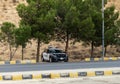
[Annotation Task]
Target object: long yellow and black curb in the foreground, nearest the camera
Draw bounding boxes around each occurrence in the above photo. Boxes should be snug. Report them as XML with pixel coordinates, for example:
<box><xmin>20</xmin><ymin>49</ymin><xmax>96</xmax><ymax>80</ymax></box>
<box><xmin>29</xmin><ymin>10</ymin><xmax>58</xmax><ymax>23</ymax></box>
<box><xmin>0</xmin><ymin>70</ymin><xmax>120</xmax><ymax>81</ymax></box>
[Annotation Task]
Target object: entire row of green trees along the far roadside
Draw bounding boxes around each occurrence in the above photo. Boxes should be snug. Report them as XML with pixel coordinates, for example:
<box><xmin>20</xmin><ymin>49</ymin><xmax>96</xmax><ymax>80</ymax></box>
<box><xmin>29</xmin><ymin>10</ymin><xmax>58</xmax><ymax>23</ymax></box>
<box><xmin>1</xmin><ymin>0</ymin><xmax>120</xmax><ymax>62</ymax></box>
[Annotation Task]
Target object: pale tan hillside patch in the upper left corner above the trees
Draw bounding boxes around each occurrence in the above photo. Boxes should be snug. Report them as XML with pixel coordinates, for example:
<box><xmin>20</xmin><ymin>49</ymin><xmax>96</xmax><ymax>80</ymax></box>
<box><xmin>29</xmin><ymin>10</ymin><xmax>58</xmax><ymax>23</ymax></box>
<box><xmin>0</xmin><ymin>0</ymin><xmax>26</xmax><ymax>25</ymax></box>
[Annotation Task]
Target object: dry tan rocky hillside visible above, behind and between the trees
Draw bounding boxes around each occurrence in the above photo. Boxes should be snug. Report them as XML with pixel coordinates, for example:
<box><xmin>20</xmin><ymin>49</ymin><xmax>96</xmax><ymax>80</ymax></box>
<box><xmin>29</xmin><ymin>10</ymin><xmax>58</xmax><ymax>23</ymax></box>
<box><xmin>0</xmin><ymin>0</ymin><xmax>120</xmax><ymax>60</ymax></box>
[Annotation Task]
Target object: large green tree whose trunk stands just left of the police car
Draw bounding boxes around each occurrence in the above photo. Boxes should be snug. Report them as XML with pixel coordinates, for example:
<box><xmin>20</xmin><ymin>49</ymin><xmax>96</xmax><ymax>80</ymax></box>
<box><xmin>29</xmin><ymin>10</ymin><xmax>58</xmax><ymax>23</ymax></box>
<box><xmin>17</xmin><ymin>0</ymin><xmax>56</xmax><ymax>62</ymax></box>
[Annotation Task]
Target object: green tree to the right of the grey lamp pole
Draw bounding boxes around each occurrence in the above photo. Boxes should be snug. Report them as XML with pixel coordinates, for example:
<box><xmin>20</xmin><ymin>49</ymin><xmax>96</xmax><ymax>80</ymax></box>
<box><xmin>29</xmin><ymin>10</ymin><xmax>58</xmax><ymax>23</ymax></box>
<box><xmin>105</xmin><ymin>6</ymin><xmax>119</xmax><ymax>54</ymax></box>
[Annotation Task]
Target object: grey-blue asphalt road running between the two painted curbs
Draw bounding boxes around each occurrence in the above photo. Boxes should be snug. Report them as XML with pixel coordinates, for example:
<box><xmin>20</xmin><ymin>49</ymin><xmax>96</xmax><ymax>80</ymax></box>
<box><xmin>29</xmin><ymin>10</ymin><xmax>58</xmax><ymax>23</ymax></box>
<box><xmin>0</xmin><ymin>61</ymin><xmax>120</xmax><ymax>72</ymax></box>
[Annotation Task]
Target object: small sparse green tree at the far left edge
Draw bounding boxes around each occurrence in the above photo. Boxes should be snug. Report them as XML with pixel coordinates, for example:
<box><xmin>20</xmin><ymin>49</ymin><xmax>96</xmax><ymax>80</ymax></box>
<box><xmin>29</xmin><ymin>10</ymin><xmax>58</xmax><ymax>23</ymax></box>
<box><xmin>1</xmin><ymin>22</ymin><xmax>17</xmax><ymax>61</ymax></box>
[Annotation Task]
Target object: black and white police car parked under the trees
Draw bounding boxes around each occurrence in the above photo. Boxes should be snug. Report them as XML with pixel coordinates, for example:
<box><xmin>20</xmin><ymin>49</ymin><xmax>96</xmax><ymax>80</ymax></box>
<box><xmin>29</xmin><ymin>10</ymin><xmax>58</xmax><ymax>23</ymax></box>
<box><xmin>41</xmin><ymin>47</ymin><xmax>68</xmax><ymax>62</ymax></box>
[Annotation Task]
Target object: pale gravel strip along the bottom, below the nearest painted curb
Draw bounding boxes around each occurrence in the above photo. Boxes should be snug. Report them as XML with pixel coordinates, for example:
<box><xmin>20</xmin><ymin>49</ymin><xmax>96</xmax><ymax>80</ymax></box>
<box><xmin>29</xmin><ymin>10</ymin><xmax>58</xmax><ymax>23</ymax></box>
<box><xmin>0</xmin><ymin>76</ymin><xmax>120</xmax><ymax>84</ymax></box>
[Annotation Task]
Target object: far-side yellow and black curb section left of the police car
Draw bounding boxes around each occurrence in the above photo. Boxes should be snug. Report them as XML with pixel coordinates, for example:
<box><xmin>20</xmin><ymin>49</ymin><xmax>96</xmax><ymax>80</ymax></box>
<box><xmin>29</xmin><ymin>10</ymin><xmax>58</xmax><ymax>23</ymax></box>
<box><xmin>0</xmin><ymin>60</ymin><xmax>36</xmax><ymax>65</ymax></box>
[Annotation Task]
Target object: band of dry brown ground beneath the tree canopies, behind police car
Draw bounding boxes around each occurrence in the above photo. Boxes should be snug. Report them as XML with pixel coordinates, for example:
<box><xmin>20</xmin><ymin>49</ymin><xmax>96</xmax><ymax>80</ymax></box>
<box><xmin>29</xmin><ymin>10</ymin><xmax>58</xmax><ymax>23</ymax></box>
<box><xmin>0</xmin><ymin>40</ymin><xmax>120</xmax><ymax>61</ymax></box>
